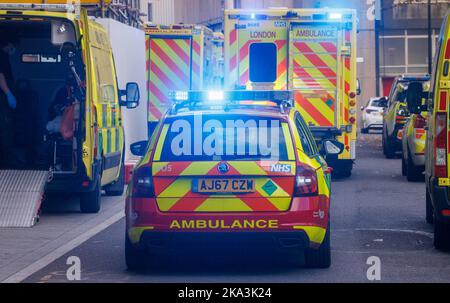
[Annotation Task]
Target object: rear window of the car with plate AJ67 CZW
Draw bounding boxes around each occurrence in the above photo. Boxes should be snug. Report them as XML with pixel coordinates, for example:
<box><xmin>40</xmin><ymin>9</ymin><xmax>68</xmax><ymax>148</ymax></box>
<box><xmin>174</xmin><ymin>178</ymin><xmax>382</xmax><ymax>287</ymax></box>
<box><xmin>160</xmin><ymin>115</ymin><xmax>293</xmax><ymax>162</ymax></box>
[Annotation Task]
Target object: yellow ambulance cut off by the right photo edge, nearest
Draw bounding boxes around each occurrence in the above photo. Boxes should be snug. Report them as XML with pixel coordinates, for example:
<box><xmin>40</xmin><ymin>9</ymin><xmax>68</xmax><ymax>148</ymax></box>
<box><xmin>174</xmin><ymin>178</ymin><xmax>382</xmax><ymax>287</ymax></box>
<box><xmin>425</xmin><ymin>14</ymin><xmax>450</xmax><ymax>249</ymax></box>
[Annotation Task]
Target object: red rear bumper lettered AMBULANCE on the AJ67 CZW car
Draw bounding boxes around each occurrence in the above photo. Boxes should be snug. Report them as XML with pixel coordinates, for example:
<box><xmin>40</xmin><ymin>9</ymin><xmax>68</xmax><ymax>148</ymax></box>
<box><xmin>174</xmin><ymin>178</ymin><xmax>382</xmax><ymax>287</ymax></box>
<box><xmin>126</xmin><ymin>196</ymin><xmax>329</xmax><ymax>251</ymax></box>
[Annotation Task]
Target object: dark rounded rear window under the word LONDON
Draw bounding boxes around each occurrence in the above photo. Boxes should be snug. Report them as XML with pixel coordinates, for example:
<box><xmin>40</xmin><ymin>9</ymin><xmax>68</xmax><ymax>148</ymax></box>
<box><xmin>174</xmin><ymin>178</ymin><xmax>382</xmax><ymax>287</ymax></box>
<box><xmin>250</xmin><ymin>43</ymin><xmax>277</xmax><ymax>83</ymax></box>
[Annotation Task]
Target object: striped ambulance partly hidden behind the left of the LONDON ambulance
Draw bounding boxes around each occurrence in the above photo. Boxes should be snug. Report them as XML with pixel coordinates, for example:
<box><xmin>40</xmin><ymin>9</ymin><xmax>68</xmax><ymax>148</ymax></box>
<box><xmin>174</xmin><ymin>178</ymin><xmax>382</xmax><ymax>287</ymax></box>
<box><xmin>145</xmin><ymin>24</ymin><xmax>214</xmax><ymax>138</ymax></box>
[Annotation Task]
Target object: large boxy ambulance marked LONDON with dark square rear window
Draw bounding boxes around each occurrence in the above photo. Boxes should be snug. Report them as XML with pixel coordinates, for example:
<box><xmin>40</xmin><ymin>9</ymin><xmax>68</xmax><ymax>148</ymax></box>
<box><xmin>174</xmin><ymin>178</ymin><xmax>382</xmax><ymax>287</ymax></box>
<box><xmin>224</xmin><ymin>8</ymin><xmax>357</xmax><ymax>177</ymax></box>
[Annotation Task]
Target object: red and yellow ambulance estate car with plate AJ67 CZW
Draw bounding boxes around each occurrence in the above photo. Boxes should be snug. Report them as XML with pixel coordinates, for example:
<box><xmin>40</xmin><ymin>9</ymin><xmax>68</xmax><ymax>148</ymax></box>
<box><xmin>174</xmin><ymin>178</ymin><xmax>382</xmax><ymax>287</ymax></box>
<box><xmin>125</xmin><ymin>91</ymin><xmax>343</xmax><ymax>269</ymax></box>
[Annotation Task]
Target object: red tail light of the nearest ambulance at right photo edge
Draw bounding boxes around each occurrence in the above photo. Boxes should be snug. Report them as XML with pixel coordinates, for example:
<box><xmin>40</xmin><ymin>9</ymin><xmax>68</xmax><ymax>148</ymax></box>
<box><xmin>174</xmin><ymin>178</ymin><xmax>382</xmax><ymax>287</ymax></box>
<box><xmin>434</xmin><ymin>113</ymin><xmax>447</xmax><ymax>178</ymax></box>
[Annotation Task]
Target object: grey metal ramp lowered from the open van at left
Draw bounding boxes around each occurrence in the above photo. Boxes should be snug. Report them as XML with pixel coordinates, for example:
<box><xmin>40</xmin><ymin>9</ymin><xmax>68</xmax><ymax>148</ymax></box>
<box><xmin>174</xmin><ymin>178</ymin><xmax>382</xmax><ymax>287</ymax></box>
<box><xmin>0</xmin><ymin>170</ymin><xmax>49</xmax><ymax>227</ymax></box>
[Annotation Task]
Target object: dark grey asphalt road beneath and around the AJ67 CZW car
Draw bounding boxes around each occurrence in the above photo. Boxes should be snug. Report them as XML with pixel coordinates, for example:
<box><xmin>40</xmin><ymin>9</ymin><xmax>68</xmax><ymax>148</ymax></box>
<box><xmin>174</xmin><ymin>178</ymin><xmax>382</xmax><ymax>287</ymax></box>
<box><xmin>25</xmin><ymin>134</ymin><xmax>450</xmax><ymax>283</ymax></box>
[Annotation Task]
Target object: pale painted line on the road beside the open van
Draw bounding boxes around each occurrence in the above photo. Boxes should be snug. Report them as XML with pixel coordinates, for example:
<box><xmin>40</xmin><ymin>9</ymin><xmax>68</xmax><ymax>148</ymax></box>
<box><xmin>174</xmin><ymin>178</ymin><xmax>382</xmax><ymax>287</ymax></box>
<box><xmin>1</xmin><ymin>210</ymin><xmax>125</xmax><ymax>283</ymax></box>
